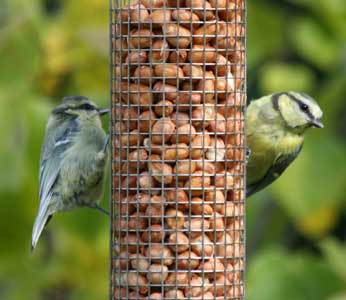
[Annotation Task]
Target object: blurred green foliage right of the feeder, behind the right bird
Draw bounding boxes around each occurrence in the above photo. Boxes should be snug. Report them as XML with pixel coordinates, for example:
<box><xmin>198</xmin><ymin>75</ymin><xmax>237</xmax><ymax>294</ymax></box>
<box><xmin>247</xmin><ymin>0</ymin><xmax>346</xmax><ymax>300</ymax></box>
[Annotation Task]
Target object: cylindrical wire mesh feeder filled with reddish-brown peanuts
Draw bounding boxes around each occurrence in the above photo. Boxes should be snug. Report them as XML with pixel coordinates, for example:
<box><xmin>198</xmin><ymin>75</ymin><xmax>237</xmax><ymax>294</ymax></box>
<box><xmin>110</xmin><ymin>0</ymin><xmax>246</xmax><ymax>300</ymax></box>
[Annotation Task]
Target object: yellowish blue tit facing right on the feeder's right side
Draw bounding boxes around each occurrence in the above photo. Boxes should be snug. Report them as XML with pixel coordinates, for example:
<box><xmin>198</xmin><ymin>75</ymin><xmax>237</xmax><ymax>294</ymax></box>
<box><xmin>246</xmin><ymin>92</ymin><xmax>323</xmax><ymax>196</ymax></box>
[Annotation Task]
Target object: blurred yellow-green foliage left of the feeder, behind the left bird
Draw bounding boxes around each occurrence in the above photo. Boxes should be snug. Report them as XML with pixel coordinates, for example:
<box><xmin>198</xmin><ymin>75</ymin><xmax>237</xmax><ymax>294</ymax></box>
<box><xmin>0</xmin><ymin>0</ymin><xmax>109</xmax><ymax>300</ymax></box>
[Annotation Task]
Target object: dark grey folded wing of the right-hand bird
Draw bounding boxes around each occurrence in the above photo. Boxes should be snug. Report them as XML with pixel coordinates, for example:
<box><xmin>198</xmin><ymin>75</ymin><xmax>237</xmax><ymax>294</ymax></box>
<box><xmin>246</xmin><ymin>144</ymin><xmax>303</xmax><ymax>197</ymax></box>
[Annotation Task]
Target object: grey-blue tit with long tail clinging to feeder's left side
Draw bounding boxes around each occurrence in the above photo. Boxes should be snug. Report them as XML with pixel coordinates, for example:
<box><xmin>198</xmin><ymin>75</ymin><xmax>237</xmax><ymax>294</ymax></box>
<box><xmin>31</xmin><ymin>96</ymin><xmax>109</xmax><ymax>250</ymax></box>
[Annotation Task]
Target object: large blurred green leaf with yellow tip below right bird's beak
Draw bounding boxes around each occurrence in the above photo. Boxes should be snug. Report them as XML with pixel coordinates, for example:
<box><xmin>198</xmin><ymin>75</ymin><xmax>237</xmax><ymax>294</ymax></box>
<box><xmin>272</xmin><ymin>135</ymin><xmax>346</xmax><ymax>237</ymax></box>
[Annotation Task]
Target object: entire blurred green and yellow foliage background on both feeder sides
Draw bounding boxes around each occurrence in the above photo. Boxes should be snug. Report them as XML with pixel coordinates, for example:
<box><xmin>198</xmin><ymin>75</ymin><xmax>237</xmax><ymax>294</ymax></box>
<box><xmin>0</xmin><ymin>0</ymin><xmax>346</xmax><ymax>300</ymax></box>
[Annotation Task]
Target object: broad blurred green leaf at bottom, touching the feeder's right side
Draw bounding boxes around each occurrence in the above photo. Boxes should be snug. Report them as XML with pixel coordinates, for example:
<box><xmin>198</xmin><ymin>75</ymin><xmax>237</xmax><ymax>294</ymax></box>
<box><xmin>247</xmin><ymin>248</ymin><xmax>342</xmax><ymax>300</ymax></box>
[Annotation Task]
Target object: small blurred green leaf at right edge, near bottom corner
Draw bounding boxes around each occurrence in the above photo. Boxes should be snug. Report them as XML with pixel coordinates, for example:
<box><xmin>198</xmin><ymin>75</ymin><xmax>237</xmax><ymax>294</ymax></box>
<box><xmin>320</xmin><ymin>238</ymin><xmax>346</xmax><ymax>283</ymax></box>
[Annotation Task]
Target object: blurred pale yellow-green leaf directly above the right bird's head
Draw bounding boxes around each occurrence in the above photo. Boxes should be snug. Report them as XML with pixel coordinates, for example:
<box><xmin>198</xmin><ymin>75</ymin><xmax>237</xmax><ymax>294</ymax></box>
<box><xmin>259</xmin><ymin>62</ymin><xmax>315</xmax><ymax>94</ymax></box>
